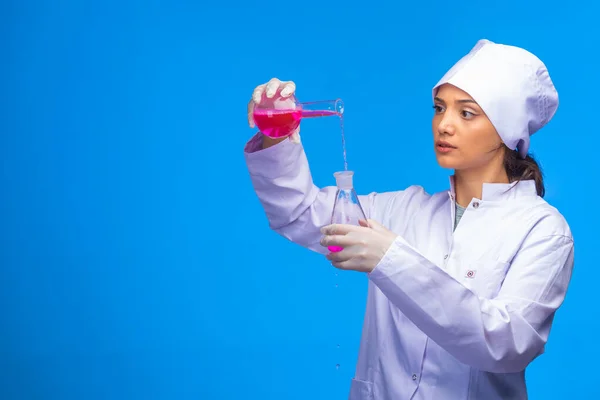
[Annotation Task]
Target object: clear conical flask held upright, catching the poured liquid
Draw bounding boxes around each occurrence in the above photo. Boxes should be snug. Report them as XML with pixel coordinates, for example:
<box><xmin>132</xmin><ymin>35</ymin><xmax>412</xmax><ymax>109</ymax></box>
<box><xmin>327</xmin><ymin>171</ymin><xmax>367</xmax><ymax>252</ymax></box>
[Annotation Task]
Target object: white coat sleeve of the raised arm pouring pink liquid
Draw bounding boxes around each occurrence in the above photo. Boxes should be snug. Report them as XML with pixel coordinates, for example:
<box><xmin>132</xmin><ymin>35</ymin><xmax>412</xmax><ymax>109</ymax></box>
<box><xmin>244</xmin><ymin>133</ymin><xmax>402</xmax><ymax>254</ymax></box>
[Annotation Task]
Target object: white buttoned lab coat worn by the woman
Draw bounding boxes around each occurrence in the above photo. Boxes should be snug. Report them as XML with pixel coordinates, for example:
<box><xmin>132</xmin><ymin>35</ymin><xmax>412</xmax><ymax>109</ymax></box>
<box><xmin>245</xmin><ymin>134</ymin><xmax>573</xmax><ymax>400</ymax></box>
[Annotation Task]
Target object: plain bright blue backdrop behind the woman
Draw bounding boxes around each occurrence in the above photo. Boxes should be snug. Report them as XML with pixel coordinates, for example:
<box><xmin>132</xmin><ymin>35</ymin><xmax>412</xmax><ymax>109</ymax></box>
<box><xmin>0</xmin><ymin>0</ymin><xmax>600</xmax><ymax>400</ymax></box>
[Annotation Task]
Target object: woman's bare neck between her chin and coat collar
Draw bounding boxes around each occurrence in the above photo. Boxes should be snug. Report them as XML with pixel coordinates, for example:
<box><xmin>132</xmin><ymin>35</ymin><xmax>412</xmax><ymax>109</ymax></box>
<box><xmin>454</xmin><ymin>166</ymin><xmax>509</xmax><ymax>207</ymax></box>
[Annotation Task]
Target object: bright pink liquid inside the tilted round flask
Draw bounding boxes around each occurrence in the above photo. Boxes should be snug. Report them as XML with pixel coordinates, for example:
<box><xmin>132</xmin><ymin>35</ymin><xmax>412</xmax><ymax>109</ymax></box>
<box><xmin>254</xmin><ymin>109</ymin><xmax>341</xmax><ymax>138</ymax></box>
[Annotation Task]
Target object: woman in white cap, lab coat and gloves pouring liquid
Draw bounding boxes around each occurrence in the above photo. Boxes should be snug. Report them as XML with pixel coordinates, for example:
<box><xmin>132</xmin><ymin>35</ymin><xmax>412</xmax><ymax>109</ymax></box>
<box><xmin>245</xmin><ymin>40</ymin><xmax>573</xmax><ymax>400</ymax></box>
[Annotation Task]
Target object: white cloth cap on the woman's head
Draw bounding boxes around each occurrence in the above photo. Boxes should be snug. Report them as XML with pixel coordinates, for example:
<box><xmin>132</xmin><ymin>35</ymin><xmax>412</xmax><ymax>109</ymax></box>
<box><xmin>433</xmin><ymin>39</ymin><xmax>558</xmax><ymax>158</ymax></box>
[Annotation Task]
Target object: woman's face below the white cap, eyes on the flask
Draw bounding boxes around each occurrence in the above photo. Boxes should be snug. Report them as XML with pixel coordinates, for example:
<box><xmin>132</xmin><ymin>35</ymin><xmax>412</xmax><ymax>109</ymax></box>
<box><xmin>432</xmin><ymin>84</ymin><xmax>505</xmax><ymax>170</ymax></box>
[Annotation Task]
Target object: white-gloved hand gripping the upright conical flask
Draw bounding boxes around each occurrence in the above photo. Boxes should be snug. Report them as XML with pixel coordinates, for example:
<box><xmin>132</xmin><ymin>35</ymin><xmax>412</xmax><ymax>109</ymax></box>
<box><xmin>321</xmin><ymin>219</ymin><xmax>398</xmax><ymax>272</ymax></box>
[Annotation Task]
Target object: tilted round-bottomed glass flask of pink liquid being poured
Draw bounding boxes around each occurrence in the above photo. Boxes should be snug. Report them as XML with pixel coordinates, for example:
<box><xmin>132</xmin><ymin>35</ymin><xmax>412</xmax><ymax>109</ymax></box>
<box><xmin>253</xmin><ymin>93</ymin><xmax>344</xmax><ymax>138</ymax></box>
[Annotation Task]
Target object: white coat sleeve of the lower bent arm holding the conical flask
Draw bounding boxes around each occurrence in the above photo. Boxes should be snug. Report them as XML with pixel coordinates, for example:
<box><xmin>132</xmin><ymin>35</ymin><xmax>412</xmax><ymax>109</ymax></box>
<box><xmin>369</xmin><ymin>216</ymin><xmax>574</xmax><ymax>373</ymax></box>
